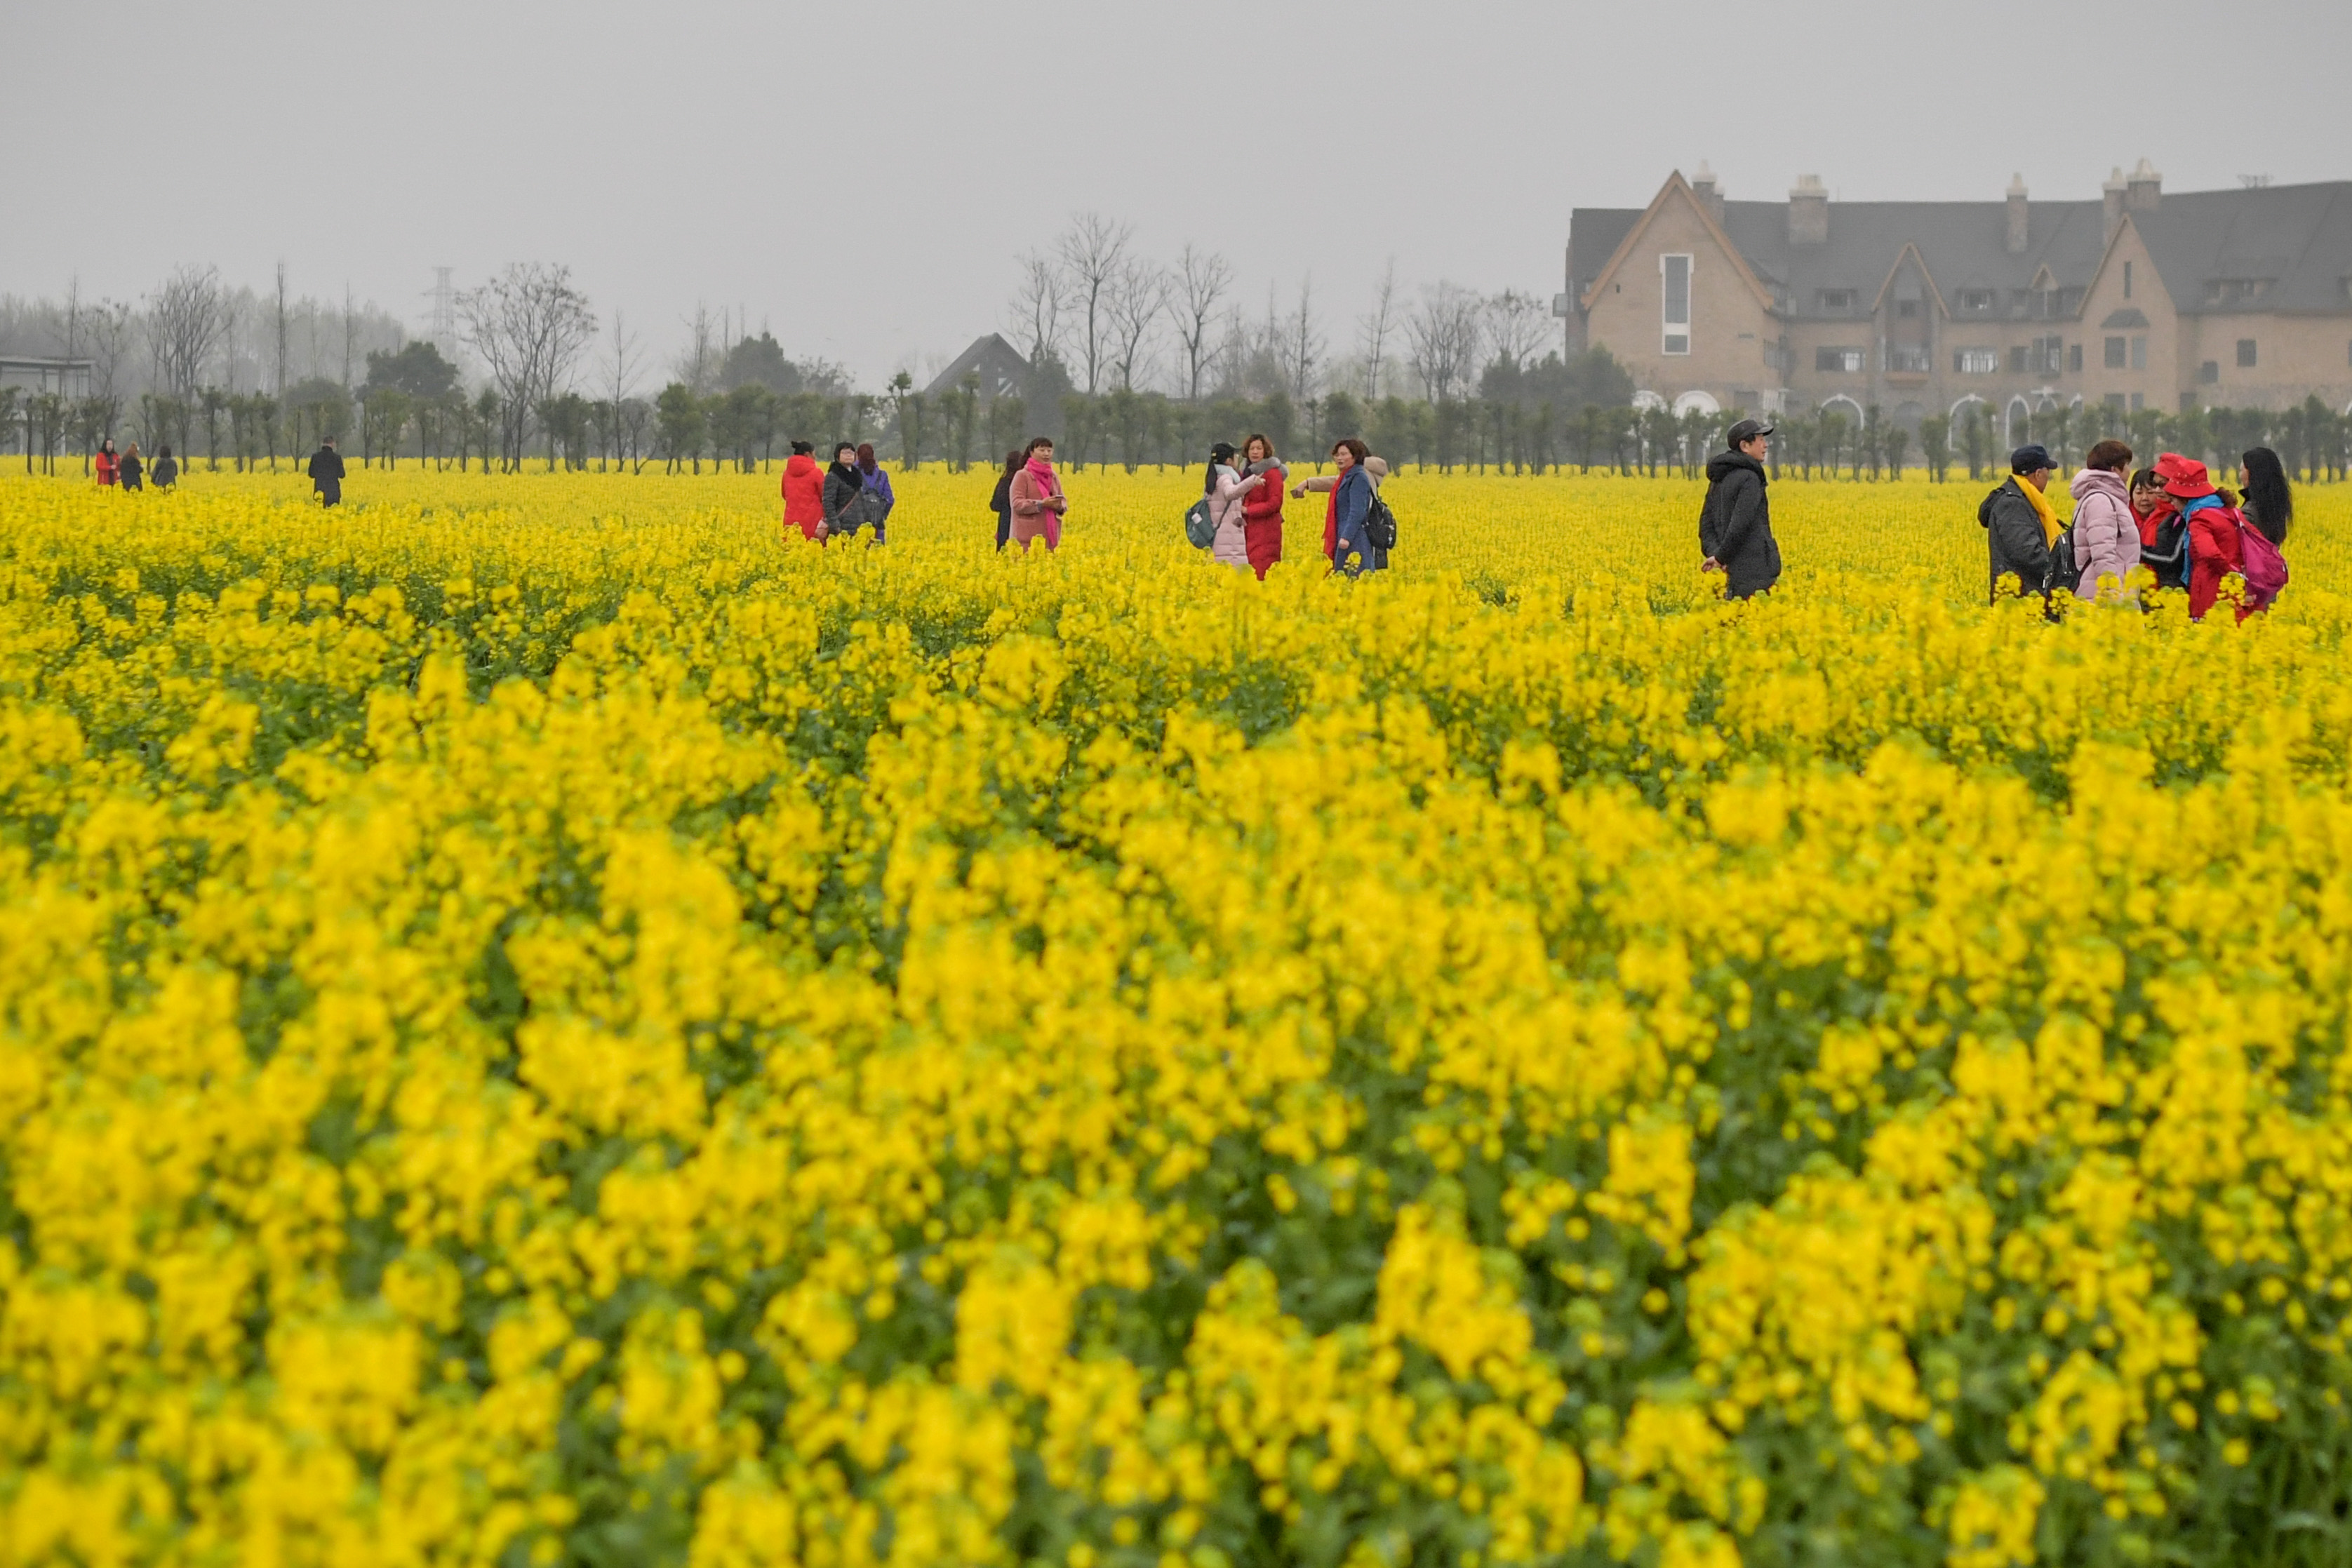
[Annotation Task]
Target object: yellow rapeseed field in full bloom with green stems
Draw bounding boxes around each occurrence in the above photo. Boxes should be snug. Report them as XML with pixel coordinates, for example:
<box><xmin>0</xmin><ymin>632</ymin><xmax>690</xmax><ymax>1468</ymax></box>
<box><xmin>0</xmin><ymin>468</ymin><xmax>2352</xmax><ymax>1568</ymax></box>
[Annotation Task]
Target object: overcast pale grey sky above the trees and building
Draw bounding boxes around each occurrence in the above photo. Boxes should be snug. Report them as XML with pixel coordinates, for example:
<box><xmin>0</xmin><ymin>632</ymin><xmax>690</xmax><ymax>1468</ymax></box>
<box><xmin>18</xmin><ymin>0</ymin><xmax>2352</xmax><ymax>383</ymax></box>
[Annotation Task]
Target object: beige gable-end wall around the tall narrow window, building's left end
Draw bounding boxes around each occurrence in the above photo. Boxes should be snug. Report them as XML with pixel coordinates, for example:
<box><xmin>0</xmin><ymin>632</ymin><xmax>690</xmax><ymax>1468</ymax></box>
<box><xmin>1588</xmin><ymin>190</ymin><xmax>1780</xmax><ymax>407</ymax></box>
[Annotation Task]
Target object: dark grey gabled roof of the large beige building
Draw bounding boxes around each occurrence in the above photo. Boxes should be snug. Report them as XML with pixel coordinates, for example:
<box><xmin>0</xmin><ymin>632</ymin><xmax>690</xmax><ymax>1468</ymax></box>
<box><xmin>1569</xmin><ymin>174</ymin><xmax>2352</xmax><ymax>320</ymax></box>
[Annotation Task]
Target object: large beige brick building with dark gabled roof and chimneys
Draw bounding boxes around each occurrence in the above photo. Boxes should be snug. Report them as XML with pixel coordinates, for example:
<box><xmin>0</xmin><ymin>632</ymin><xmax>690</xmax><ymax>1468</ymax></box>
<box><xmin>1559</xmin><ymin>160</ymin><xmax>2352</xmax><ymax>430</ymax></box>
